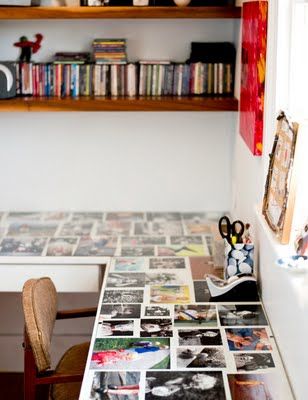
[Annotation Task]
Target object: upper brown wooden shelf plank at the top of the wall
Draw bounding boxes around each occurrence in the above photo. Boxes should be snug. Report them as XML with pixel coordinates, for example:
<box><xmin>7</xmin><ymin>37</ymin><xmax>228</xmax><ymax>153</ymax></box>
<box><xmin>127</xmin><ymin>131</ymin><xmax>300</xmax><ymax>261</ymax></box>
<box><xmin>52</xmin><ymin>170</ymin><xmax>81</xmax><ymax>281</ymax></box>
<box><xmin>0</xmin><ymin>6</ymin><xmax>241</xmax><ymax>20</ymax></box>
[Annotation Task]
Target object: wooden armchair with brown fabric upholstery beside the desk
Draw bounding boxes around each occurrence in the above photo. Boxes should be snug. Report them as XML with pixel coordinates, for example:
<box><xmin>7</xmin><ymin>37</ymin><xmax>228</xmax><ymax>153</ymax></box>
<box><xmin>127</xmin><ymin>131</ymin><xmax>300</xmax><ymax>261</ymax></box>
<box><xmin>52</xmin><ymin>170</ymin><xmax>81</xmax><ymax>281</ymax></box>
<box><xmin>22</xmin><ymin>278</ymin><xmax>96</xmax><ymax>400</ymax></box>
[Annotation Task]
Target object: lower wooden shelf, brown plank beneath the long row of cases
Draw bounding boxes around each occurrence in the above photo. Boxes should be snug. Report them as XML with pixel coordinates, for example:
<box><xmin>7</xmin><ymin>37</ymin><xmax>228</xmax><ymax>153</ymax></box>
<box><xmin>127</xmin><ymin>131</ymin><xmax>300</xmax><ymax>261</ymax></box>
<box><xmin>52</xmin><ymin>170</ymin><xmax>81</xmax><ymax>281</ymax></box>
<box><xmin>0</xmin><ymin>97</ymin><xmax>238</xmax><ymax>112</ymax></box>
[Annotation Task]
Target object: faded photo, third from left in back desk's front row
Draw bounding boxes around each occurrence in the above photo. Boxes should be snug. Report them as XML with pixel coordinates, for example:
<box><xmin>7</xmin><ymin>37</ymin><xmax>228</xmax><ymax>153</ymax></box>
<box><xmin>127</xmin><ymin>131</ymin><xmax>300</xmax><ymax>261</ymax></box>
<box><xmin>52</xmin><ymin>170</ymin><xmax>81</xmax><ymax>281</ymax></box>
<box><xmin>74</xmin><ymin>236</ymin><xmax>117</xmax><ymax>257</ymax></box>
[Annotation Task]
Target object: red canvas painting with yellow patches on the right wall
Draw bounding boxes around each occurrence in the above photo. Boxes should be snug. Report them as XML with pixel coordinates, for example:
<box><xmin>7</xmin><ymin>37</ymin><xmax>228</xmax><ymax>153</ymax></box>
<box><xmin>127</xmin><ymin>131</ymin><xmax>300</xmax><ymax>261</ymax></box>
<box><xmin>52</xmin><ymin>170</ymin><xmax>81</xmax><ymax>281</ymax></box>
<box><xmin>240</xmin><ymin>1</ymin><xmax>267</xmax><ymax>156</ymax></box>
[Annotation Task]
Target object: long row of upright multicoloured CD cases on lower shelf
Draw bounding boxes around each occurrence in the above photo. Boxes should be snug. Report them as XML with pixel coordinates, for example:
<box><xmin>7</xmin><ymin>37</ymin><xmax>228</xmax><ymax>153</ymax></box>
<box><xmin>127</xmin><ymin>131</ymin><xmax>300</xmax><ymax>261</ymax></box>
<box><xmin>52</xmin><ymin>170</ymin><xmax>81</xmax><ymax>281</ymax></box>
<box><xmin>16</xmin><ymin>61</ymin><xmax>233</xmax><ymax>97</ymax></box>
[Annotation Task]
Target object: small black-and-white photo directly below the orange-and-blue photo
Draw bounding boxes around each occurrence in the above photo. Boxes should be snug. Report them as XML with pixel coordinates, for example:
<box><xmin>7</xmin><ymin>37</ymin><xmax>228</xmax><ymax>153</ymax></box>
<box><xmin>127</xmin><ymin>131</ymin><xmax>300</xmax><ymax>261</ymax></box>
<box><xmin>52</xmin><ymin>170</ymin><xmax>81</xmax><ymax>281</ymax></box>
<box><xmin>233</xmin><ymin>353</ymin><xmax>275</xmax><ymax>372</ymax></box>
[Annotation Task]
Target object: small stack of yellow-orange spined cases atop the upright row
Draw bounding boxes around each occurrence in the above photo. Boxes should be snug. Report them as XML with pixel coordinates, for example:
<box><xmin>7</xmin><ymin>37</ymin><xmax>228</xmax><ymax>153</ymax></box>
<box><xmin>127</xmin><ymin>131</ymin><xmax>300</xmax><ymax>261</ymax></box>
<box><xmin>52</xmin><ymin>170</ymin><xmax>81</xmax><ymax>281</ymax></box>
<box><xmin>92</xmin><ymin>39</ymin><xmax>127</xmax><ymax>64</ymax></box>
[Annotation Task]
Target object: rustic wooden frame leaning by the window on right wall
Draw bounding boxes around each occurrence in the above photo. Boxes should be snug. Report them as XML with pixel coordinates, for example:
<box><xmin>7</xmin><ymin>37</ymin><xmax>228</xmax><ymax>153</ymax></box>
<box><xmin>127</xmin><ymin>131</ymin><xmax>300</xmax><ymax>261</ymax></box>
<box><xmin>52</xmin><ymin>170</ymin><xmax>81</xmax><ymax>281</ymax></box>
<box><xmin>262</xmin><ymin>112</ymin><xmax>298</xmax><ymax>244</ymax></box>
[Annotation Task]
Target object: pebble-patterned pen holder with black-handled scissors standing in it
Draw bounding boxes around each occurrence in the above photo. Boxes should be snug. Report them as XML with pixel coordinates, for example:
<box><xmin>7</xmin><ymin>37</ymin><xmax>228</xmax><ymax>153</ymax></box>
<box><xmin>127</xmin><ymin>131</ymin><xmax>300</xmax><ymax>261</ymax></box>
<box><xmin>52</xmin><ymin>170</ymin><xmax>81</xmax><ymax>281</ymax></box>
<box><xmin>224</xmin><ymin>239</ymin><xmax>254</xmax><ymax>279</ymax></box>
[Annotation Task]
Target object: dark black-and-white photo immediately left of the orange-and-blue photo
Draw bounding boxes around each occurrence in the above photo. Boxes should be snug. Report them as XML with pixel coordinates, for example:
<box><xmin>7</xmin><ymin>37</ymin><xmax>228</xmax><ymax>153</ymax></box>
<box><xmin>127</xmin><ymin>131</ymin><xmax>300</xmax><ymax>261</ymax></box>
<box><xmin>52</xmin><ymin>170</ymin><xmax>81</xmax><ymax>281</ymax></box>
<box><xmin>178</xmin><ymin>329</ymin><xmax>222</xmax><ymax>346</ymax></box>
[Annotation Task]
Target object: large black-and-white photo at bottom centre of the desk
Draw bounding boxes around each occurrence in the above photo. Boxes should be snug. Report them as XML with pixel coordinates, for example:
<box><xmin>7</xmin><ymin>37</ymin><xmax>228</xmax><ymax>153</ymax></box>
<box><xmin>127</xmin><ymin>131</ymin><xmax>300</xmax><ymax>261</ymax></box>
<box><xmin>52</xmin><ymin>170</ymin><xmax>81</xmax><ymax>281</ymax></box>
<box><xmin>145</xmin><ymin>371</ymin><xmax>226</xmax><ymax>400</ymax></box>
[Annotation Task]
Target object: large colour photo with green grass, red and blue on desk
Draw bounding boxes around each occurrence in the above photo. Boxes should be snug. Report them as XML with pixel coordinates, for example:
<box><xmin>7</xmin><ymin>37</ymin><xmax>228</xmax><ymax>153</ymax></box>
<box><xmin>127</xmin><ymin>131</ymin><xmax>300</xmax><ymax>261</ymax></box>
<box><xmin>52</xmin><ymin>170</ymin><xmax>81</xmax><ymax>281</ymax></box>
<box><xmin>90</xmin><ymin>338</ymin><xmax>170</xmax><ymax>371</ymax></box>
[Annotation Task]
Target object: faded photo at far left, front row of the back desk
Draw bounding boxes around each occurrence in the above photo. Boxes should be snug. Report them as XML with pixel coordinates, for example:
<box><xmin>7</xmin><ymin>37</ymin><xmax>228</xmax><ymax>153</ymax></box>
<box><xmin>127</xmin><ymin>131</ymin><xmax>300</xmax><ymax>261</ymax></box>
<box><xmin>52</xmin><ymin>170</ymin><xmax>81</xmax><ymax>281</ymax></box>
<box><xmin>0</xmin><ymin>238</ymin><xmax>47</xmax><ymax>256</ymax></box>
